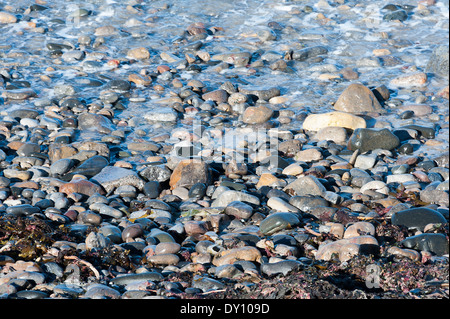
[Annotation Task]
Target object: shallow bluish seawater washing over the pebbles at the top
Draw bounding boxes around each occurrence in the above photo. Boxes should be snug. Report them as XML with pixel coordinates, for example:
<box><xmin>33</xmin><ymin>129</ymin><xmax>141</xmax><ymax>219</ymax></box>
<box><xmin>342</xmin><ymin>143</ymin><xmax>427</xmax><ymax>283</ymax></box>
<box><xmin>0</xmin><ymin>0</ymin><xmax>449</xmax><ymax>159</ymax></box>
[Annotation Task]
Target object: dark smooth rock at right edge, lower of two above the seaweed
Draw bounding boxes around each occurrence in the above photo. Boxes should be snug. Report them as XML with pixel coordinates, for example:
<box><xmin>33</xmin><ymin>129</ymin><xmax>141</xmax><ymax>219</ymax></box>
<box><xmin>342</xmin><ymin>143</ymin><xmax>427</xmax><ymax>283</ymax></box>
<box><xmin>400</xmin><ymin>234</ymin><xmax>448</xmax><ymax>256</ymax></box>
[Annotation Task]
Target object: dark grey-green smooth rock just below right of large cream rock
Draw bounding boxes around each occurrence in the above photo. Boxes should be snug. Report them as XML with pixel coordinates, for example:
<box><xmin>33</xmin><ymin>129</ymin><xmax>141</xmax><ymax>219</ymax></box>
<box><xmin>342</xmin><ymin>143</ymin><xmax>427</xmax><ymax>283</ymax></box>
<box><xmin>347</xmin><ymin>128</ymin><xmax>400</xmax><ymax>153</ymax></box>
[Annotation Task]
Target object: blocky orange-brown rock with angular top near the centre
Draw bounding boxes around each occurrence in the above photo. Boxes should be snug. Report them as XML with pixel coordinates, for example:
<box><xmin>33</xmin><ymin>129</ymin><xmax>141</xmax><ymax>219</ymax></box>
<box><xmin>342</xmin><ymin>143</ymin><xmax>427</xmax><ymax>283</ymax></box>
<box><xmin>169</xmin><ymin>159</ymin><xmax>211</xmax><ymax>189</ymax></box>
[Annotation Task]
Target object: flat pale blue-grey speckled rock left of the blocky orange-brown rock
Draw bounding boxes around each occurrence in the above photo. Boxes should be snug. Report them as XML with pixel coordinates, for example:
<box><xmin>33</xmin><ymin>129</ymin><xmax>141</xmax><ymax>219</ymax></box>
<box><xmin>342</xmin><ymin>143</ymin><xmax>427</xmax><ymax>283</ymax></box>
<box><xmin>91</xmin><ymin>166</ymin><xmax>145</xmax><ymax>192</ymax></box>
